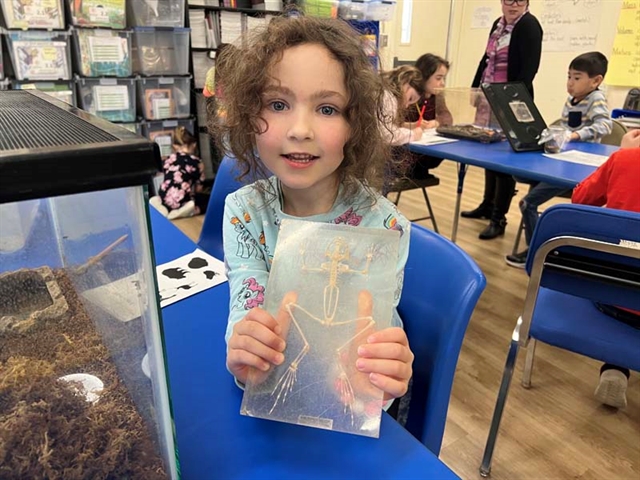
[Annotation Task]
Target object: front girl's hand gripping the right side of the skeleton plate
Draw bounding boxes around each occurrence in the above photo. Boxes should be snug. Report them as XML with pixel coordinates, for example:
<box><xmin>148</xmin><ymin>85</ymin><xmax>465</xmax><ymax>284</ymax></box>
<box><xmin>356</xmin><ymin>327</ymin><xmax>414</xmax><ymax>401</ymax></box>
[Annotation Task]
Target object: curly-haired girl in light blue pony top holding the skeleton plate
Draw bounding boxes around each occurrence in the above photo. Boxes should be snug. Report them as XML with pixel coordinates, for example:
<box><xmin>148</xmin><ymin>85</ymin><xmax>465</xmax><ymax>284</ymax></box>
<box><xmin>214</xmin><ymin>16</ymin><xmax>413</xmax><ymax>401</ymax></box>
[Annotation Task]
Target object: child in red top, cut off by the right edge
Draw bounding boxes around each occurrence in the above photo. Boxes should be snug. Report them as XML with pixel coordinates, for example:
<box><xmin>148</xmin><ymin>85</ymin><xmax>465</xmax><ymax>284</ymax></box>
<box><xmin>571</xmin><ymin>130</ymin><xmax>640</xmax><ymax>408</ymax></box>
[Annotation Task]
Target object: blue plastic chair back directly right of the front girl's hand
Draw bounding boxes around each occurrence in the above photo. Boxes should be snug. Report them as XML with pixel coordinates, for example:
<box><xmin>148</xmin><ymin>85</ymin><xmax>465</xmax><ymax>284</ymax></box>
<box><xmin>398</xmin><ymin>224</ymin><xmax>486</xmax><ymax>456</ymax></box>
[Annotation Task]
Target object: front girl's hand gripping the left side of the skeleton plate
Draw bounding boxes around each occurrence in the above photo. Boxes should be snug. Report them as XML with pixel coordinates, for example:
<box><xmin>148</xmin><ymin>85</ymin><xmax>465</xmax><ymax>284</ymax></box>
<box><xmin>227</xmin><ymin>293</ymin><xmax>296</xmax><ymax>384</ymax></box>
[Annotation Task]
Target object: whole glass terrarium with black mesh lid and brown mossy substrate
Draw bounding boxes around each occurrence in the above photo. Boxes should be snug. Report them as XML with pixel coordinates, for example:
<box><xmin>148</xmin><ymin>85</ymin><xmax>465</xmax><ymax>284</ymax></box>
<box><xmin>0</xmin><ymin>90</ymin><xmax>179</xmax><ymax>479</ymax></box>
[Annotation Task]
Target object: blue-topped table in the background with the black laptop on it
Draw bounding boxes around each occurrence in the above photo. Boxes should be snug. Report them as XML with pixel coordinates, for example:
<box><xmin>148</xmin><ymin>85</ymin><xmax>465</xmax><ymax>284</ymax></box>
<box><xmin>409</xmin><ymin>140</ymin><xmax>618</xmax><ymax>242</ymax></box>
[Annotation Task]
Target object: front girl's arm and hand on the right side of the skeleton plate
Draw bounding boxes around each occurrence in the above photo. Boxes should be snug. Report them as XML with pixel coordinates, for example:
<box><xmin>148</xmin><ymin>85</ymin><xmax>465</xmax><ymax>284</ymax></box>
<box><xmin>356</xmin><ymin>217</ymin><xmax>414</xmax><ymax>400</ymax></box>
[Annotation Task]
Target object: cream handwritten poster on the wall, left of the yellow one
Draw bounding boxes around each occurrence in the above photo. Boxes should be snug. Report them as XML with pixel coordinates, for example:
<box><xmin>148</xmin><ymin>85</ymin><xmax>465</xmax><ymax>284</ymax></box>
<box><xmin>539</xmin><ymin>0</ymin><xmax>602</xmax><ymax>52</ymax></box>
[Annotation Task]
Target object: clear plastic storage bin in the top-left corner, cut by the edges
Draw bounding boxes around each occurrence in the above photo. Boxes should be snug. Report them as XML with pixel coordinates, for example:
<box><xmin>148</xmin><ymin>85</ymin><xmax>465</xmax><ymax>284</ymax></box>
<box><xmin>0</xmin><ymin>0</ymin><xmax>64</xmax><ymax>29</ymax></box>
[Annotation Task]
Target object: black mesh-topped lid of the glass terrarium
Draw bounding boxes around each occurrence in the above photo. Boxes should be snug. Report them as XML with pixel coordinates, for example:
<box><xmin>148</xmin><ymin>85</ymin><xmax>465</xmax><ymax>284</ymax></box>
<box><xmin>0</xmin><ymin>90</ymin><xmax>162</xmax><ymax>203</ymax></box>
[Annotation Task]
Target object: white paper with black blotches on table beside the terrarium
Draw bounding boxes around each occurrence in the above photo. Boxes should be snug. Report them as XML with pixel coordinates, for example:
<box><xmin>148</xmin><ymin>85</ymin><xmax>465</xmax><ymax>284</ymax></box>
<box><xmin>156</xmin><ymin>248</ymin><xmax>227</xmax><ymax>308</ymax></box>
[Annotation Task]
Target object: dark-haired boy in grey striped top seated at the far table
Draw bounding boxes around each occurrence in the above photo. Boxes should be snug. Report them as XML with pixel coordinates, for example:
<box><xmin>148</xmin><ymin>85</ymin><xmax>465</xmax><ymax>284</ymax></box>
<box><xmin>505</xmin><ymin>52</ymin><xmax>612</xmax><ymax>268</ymax></box>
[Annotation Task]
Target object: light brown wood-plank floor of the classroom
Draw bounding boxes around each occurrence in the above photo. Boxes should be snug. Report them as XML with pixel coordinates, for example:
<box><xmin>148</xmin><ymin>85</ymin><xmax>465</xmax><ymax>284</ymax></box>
<box><xmin>175</xmin><ymin>161</ymin><xmax>640</xmax><ymax>480</ymax></box>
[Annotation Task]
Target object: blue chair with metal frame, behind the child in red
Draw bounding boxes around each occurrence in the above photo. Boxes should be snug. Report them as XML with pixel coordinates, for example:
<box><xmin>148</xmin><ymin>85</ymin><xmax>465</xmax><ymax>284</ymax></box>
<box><xmin>480</xmin><ymin>204</ymin><xmax>640</xmax><ymax>477</ymax></box>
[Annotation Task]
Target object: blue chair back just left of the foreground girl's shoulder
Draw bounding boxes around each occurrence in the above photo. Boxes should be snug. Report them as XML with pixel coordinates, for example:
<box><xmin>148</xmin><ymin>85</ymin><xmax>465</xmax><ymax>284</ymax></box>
<box><xmin>198</xmin><ymin>157</ymin><xmax>250</xmax><ymax>259</ymax></box>
